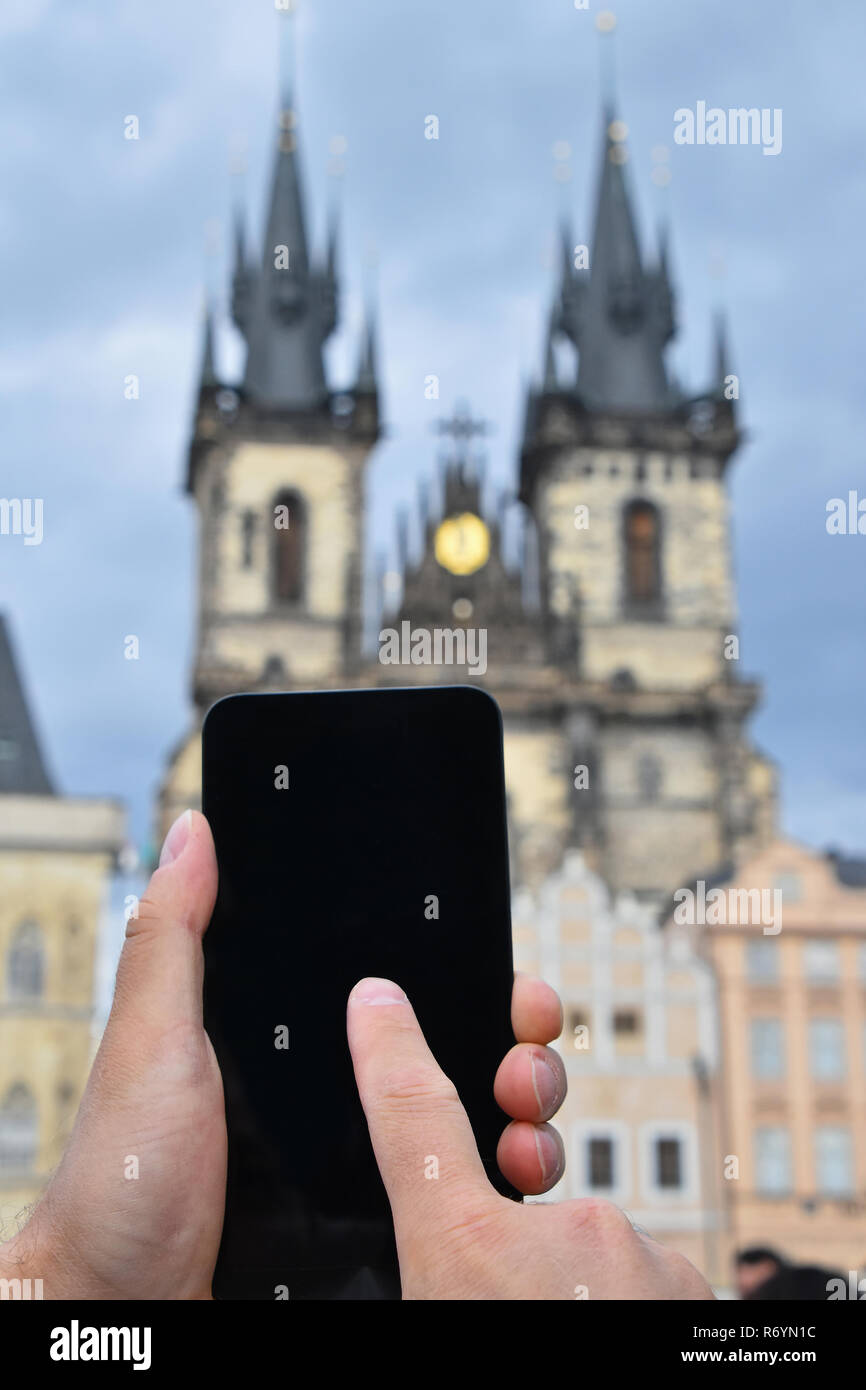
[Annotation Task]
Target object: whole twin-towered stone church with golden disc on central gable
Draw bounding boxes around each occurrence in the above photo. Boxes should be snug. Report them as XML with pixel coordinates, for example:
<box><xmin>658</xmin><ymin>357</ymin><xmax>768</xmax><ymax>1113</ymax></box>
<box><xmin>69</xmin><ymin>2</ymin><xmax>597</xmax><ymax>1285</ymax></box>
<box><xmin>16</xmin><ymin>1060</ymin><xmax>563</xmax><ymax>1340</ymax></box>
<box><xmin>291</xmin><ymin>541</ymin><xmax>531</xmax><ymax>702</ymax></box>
<box><xmin>158</xmin><ymin>86</ymin><xmax>774</xmax><ymax>902</ymax></box>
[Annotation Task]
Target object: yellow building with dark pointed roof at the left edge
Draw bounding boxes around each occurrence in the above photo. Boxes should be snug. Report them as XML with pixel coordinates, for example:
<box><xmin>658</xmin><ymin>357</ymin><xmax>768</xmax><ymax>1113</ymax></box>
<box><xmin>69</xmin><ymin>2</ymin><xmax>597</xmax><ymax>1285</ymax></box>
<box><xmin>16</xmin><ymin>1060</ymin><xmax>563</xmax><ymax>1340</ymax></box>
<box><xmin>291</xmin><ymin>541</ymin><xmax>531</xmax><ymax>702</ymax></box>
<box><xmin>0</xmin><ymin>616</ymin><xmax>124</xmax><ymax>1238</ymax></box>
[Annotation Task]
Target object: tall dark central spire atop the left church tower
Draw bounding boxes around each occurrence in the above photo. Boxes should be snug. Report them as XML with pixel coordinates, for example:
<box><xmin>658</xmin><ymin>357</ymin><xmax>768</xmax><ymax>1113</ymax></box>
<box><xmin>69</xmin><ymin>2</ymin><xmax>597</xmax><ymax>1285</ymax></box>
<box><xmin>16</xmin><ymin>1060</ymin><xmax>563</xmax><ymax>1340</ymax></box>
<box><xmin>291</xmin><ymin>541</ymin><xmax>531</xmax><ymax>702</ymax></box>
<box><xmin>243</xmin><ymin>99</ymin><xmax>336</xmax><ymax>413</ymax></box>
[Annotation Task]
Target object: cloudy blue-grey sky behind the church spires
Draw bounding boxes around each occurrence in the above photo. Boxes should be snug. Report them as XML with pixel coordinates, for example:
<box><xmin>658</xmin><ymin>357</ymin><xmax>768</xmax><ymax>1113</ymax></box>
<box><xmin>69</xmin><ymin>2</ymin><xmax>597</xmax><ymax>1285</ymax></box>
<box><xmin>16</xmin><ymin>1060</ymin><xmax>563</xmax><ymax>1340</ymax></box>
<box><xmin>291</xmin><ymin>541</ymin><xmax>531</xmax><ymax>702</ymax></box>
<box><xmin>0</xmin><ymin>0</ymin><xmax>866</xmax><ymax>878</ymax></box>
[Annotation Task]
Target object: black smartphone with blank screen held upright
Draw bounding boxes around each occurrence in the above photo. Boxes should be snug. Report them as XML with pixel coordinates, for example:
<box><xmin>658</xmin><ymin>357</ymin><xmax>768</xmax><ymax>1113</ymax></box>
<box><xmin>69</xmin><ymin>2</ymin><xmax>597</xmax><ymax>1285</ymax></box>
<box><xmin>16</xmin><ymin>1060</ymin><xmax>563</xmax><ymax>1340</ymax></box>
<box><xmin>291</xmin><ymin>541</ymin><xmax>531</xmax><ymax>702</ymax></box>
<box><xmin>203</xmin><ymin>685</ymin><xmax>520</xmax><ymax>1300</ymax></box>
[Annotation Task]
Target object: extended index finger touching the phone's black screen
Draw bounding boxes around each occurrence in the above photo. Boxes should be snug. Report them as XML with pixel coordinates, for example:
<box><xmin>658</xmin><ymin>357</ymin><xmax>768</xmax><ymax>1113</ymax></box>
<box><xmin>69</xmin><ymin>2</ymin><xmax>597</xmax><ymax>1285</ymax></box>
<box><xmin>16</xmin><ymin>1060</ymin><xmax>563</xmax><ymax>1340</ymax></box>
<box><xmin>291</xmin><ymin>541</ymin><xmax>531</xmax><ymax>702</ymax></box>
<box><xmin>348</xmin><ymin>979</ymin><xmax>498</xmax><ymax>1252</ymax></box>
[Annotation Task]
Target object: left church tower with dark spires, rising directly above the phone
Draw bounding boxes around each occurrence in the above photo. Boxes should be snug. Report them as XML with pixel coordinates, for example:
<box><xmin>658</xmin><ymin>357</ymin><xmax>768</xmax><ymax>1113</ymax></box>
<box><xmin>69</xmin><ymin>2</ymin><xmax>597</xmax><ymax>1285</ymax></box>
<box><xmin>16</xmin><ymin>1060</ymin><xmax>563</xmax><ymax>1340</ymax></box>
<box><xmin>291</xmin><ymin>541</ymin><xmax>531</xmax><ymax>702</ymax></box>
<box><xmin>160</xmin><ymin>89</ymin><xmax>379</xmax><ymax>834</ymax></box>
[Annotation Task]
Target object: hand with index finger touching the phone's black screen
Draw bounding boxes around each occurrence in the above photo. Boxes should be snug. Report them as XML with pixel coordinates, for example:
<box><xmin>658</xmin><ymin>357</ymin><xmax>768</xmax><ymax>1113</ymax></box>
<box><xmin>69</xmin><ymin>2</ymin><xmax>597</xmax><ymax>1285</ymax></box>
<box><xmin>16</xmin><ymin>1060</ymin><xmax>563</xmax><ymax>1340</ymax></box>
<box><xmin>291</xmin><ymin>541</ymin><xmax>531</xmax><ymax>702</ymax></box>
<box><xmin>348</xmin><ymin>980</ymin><xmax>713</xmax><ymax>1300</ymax></box>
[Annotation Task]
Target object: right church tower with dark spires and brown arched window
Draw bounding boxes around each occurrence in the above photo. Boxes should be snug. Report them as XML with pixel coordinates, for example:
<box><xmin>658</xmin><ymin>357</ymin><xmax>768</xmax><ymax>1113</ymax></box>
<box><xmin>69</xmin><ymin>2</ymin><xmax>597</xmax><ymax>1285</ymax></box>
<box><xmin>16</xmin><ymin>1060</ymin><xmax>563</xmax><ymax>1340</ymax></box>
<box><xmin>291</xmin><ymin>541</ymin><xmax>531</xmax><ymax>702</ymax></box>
<box><xmin>520</xmin><ymin>102</ymin><xmax>773</xmax><ymax>898</ymax></box>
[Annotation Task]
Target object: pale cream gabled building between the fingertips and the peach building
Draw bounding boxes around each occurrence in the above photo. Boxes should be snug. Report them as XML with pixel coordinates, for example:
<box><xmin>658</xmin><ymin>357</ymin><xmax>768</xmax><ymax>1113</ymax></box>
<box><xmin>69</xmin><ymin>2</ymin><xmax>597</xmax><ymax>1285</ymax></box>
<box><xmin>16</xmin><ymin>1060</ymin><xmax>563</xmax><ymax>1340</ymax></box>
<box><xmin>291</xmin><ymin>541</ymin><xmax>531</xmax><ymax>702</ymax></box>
<box><xmin>513</xmin><ymin>852</ymin><xmax>728</xmax><ymax>1284</ymax></box>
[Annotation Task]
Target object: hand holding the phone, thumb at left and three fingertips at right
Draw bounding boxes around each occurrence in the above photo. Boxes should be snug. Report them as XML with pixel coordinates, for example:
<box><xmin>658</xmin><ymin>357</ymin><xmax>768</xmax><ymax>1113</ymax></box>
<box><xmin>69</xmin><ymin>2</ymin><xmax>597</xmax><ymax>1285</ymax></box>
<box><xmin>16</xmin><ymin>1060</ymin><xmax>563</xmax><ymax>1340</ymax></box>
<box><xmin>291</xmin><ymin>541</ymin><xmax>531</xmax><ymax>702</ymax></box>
<box><xmin>0</xmin><ymin>812</ymin><xmax>564</xmax><ymax>1300</ymax></box>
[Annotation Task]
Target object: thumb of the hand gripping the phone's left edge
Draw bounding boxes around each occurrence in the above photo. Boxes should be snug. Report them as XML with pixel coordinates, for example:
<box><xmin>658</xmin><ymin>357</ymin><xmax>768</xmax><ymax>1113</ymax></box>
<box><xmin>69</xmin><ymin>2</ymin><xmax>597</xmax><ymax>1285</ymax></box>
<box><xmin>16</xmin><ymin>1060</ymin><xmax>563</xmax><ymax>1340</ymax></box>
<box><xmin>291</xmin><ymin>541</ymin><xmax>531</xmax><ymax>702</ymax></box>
<box><xmin>106</xmin><ymin>810</ymin><xmax>217</xmax><ymax>1045</ymax></box>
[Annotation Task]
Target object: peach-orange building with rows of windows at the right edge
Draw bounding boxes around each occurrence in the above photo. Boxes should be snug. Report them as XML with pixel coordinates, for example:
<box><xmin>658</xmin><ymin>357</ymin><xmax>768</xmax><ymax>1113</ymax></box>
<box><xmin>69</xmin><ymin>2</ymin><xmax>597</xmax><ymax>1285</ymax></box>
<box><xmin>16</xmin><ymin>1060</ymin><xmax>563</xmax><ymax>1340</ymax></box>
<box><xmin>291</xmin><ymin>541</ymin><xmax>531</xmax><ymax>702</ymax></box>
<box><xmin>666</xmin><ymin>840</ymin><xmax>866</xmax><ymax>1270</ymax></box>
